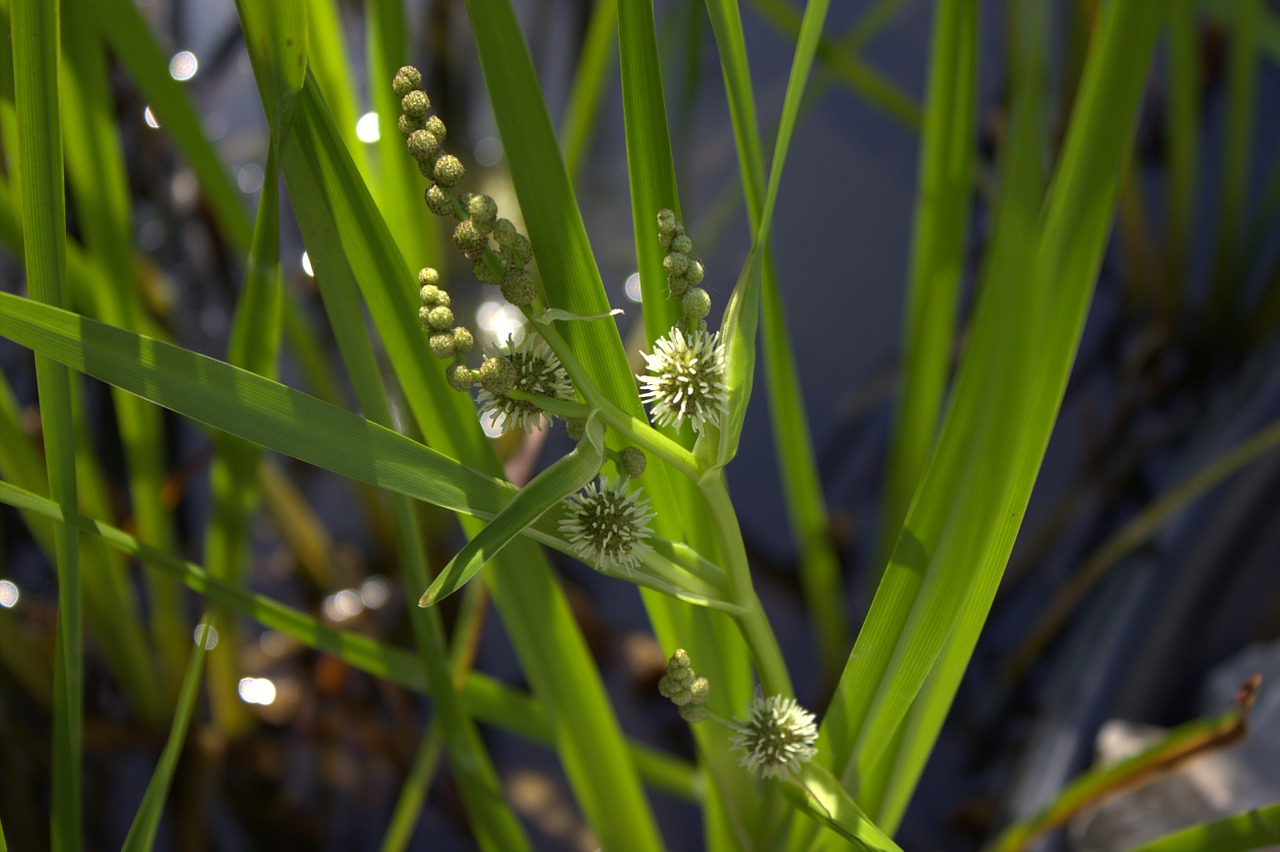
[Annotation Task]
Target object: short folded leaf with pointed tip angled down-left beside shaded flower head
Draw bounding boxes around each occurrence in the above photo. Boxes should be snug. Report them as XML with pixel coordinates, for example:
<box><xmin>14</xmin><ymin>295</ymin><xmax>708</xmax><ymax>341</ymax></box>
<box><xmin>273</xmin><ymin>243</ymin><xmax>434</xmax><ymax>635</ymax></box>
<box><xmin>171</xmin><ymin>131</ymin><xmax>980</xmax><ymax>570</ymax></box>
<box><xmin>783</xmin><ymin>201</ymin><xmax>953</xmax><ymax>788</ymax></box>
<box><xmin>417</xmin><ymin>418</ymin><xmax>604</xmax><ymax>606</ymax></box>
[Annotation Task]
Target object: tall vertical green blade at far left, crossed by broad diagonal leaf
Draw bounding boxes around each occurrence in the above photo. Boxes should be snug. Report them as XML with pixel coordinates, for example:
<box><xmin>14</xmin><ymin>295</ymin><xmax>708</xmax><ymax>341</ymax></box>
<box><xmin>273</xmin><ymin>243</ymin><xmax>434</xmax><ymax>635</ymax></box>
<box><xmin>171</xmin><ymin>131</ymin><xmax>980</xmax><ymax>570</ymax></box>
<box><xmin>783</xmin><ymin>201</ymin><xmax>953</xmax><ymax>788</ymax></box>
<box><xmin>10</xmin><ymin>0</ymin><xmax>84</xmax><ymax>852</ymax></box>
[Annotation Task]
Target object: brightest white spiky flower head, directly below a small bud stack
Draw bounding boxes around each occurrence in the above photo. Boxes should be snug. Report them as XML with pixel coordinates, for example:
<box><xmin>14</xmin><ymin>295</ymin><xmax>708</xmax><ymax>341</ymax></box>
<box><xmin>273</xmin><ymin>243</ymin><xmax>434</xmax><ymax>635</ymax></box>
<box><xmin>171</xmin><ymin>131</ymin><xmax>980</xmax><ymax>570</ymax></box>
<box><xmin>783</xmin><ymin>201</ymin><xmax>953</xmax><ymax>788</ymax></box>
<box><xmin>636</xmin><ymin>329</ymin><xmax>728</xmax><ymax>432</ymax></box>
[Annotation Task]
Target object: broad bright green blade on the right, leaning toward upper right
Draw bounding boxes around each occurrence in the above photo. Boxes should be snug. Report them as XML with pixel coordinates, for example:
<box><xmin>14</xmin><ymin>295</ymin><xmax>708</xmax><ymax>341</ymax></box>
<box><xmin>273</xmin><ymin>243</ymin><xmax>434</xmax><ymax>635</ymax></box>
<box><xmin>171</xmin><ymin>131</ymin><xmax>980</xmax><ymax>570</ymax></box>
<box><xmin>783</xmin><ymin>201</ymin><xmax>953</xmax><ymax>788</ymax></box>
<box><xmin>824</xmin><ymin>4</ymin><xmax>1160</xmax><ymax>830</ymax></box>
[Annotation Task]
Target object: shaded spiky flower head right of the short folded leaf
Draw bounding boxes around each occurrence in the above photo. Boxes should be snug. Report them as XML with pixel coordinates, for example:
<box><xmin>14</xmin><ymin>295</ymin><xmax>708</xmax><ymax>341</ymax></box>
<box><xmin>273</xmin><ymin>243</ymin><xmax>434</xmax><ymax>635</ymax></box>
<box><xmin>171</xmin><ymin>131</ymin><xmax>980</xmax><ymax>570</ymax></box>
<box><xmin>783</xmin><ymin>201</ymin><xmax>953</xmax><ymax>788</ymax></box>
<box><xmin>559</xmin><ymin>476</ymin><xmax>654</xmax><ymax>572</ymax></box>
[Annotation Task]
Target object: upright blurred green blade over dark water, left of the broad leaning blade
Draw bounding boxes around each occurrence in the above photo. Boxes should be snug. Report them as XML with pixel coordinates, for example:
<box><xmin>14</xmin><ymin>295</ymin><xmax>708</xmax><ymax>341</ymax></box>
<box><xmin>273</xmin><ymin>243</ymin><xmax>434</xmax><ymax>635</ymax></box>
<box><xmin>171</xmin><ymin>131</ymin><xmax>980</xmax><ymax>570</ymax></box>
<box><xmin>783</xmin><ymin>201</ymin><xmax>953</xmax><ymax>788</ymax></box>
<box><xmin>876</xmin><ymin>0</ymin><xmax>978</xmax><ymax>565</ymax></box>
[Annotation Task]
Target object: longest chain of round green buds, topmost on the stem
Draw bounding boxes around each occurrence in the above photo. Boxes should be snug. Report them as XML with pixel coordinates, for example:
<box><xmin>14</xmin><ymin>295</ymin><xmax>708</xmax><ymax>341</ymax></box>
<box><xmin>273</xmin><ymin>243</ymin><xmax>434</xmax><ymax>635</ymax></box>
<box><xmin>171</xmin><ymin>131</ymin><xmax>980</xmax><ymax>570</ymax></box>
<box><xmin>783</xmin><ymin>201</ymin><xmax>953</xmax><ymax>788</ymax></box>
<box><xmin>392</xmin><ymin>65</ymin><xmax>538</xmax><ymax>307</ymax></box>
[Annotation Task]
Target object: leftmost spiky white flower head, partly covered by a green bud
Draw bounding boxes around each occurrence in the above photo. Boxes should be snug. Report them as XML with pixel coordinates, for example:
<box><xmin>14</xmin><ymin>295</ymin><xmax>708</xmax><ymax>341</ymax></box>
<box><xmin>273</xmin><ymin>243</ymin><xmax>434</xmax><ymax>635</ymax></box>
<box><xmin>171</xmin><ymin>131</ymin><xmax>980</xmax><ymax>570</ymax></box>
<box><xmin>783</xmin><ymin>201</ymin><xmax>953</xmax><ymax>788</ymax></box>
<box><xmin>476</xmin><ymin>334</ymin><xmax>573</xmax><ymax>432</ymax></box>
